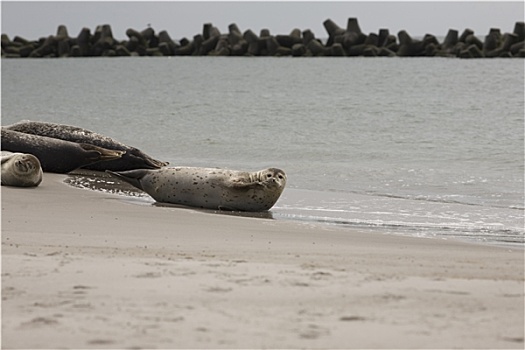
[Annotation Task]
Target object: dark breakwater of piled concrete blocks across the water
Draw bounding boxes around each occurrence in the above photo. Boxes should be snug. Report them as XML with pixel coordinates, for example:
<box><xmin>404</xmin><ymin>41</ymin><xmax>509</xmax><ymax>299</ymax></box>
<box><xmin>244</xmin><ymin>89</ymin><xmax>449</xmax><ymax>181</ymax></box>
<box><xmin>2</xmin><ymin>17</ymin><xmax>525</xmax><ymax>58</ymax></box>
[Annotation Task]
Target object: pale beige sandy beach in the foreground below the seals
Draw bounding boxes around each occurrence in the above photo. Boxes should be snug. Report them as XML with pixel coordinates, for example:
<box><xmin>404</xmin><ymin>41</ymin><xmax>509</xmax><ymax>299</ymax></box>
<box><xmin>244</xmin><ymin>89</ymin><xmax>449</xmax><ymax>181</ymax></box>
<box><xmin>1</xmin><ymin>174</ymin><xmax>524</xmax><ymax>349</ymax></box>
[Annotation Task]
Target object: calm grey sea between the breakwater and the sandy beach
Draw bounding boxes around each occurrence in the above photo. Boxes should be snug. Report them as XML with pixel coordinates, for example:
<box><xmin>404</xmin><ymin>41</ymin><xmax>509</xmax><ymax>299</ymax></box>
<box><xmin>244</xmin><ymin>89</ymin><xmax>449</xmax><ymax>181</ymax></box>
<box><xmin>1</xmin><ymin>57</ymin><xmax>524</xmax><ymax>244</ymax></box>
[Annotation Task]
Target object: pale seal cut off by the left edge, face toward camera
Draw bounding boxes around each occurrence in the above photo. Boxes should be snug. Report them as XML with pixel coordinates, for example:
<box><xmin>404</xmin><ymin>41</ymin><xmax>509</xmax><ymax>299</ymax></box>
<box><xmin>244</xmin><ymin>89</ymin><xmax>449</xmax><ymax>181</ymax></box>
<box><xmin>1</xmin><ymin>151</ymin><xmax>42</xmax><ymax>187</ymax></box>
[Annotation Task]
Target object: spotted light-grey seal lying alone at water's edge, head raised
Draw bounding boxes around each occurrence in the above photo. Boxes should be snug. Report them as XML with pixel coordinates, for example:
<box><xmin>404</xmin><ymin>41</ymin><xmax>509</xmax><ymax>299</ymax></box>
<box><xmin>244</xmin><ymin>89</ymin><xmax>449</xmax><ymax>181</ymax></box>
<box><xmin>108</xmin><ymin>167</ymin><xmax>286</xmax><ymax>211</ymax></box>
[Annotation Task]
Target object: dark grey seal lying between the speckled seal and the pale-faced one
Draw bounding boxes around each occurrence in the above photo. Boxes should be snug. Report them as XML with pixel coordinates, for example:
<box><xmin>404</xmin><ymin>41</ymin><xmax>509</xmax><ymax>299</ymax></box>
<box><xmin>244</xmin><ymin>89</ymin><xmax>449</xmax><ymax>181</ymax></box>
<box><xmin>1</xmin><ymin>128</ymin><xmax>124</xmax><ymax>174</ymax></box>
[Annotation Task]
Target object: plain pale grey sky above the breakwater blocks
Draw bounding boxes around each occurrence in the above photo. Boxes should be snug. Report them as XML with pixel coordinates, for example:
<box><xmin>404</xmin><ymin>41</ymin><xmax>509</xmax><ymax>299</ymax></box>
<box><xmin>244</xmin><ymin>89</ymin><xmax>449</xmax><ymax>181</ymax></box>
<box><xmin>1</xmin><ymin>1</ymin><xmax>524</xmax><ymax>40</ymax></box>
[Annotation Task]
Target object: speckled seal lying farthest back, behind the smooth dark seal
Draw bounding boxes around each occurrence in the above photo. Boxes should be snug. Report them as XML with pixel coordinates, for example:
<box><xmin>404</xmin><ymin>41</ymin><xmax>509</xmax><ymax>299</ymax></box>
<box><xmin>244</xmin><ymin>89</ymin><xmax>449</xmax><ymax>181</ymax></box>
<box><xmin>5</xmin><ymin>120</ymin><xmax>168</xmax><ymax>171</ymax></box>
